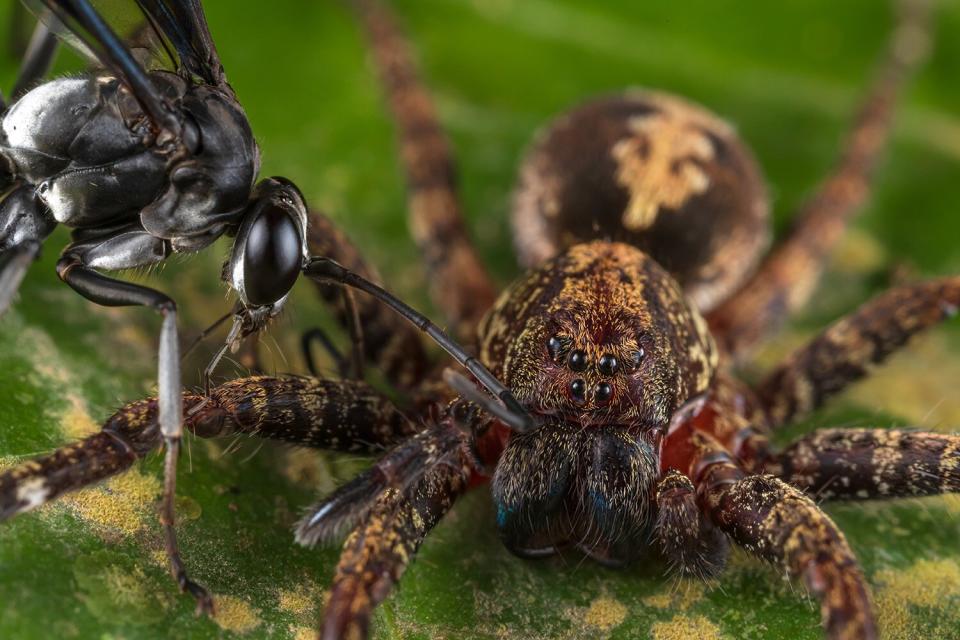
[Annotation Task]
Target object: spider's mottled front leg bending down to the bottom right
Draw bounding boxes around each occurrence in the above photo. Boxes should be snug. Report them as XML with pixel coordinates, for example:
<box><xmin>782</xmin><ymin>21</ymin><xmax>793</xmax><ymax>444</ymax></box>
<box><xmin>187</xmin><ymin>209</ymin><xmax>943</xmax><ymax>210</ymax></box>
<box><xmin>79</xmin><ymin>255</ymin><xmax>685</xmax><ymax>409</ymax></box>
<box><xmin>696</xmin><ymin>442</ymin><xmax>877</xmax><ymax>640</ymax></box>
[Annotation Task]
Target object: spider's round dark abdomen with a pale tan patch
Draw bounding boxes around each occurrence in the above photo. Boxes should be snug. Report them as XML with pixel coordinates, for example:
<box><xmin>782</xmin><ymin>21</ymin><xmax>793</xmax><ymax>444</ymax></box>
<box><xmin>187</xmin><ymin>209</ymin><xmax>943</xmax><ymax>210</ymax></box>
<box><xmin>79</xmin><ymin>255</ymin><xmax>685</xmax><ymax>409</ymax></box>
<box><xmin>512</xmin><ymin>91</ymin><xmax>769</xmax><ymax>311</ymax></box>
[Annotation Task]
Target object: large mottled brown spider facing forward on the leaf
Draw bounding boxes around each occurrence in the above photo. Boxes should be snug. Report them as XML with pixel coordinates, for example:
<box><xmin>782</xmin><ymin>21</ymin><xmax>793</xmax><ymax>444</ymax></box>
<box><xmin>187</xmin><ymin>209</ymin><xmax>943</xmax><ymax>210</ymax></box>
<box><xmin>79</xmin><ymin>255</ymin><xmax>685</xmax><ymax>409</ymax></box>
<box><xmin>0</xmin><ymin>0</ymin><xmax>960</xmax><ymax>639</ymax></box>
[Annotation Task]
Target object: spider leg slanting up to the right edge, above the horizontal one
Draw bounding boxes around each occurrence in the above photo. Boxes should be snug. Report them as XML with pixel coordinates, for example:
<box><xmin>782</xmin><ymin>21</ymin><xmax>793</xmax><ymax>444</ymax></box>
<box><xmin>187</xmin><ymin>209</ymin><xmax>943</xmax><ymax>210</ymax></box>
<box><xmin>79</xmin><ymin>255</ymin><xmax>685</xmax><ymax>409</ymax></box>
<box><xmin>757</xmin><ymin>276</ymin><xmax>960</xmax><ymax>427</ymax></box>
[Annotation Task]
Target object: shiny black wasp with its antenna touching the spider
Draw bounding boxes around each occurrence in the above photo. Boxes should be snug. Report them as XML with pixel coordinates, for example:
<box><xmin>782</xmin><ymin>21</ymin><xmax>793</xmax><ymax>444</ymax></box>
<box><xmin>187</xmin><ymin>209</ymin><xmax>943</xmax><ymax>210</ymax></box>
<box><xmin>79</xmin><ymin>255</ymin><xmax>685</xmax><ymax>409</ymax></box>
<box><xmin>0</xmin><ymin>0</ymin><xmax>529</xmax><ymax>609</ymax></box>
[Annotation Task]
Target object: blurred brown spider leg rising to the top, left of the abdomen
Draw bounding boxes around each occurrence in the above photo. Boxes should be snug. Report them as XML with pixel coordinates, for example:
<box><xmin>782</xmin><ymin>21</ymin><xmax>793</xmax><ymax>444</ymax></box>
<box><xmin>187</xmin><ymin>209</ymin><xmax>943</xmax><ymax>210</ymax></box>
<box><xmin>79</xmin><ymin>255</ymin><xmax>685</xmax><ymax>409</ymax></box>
<box><xmin>352</xmin><ymin>0</ymin><xmax>496</xmax><ymax>336</ymax></box>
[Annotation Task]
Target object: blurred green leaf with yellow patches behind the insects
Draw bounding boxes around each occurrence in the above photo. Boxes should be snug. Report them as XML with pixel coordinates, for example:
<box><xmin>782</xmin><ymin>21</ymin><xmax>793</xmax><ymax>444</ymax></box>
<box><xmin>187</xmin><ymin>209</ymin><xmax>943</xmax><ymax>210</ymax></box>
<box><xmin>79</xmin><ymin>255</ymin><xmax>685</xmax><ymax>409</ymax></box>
<box><xmin>0</xmin><ymin>0</ymin><xmax>960</xmax><ymax>639</ymax></box>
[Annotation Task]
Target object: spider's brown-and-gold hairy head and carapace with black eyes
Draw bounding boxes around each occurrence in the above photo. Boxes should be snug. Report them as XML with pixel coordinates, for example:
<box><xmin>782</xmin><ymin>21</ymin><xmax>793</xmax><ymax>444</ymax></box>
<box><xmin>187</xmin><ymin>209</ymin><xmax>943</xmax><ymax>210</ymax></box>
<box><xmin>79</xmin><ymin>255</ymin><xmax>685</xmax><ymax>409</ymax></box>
<box><xmin>480</xmin><ymin>242</ymin><xmax>716</xmax><ymax>429</ymax></box>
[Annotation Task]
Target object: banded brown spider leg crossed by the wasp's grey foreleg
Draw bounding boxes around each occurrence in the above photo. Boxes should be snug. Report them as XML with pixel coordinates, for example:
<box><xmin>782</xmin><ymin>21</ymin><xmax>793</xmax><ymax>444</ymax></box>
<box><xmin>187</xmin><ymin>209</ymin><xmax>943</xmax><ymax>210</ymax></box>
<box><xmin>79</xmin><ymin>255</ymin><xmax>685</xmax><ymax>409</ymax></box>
<box><xmin>0</xmin><ymin>377</ymin><xmax>416</xmax><ymax>520</ymax></box>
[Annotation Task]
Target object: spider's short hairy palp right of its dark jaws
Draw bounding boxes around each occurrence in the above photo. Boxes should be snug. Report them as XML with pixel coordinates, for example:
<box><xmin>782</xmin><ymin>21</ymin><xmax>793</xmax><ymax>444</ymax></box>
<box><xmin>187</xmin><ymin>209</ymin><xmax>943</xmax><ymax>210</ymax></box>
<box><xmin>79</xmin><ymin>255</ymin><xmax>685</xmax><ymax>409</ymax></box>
<box><xmin>654</xmin><ymin>469</ymin><xmax>730</xmax><ymax>579</ymax></box>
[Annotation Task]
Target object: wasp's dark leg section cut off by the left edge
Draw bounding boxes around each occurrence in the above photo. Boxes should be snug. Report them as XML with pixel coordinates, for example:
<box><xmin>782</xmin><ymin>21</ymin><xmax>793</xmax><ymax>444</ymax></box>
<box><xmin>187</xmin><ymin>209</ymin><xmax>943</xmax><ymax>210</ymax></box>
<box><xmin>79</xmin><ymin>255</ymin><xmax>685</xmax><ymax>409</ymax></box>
<box><xmin>0</xmin><ymin>185</ymin><xmax>57</xmax><ymax>315</ymax></box>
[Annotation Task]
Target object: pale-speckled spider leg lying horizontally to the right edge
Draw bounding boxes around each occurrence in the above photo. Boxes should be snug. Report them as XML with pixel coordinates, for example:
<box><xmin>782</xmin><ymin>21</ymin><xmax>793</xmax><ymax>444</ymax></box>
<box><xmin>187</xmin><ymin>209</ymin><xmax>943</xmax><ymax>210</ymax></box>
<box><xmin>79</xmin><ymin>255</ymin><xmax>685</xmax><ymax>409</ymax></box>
<box><xmin>766</xmin><ymin>429</ymin><xmax>960</xmax><ymax>500</ymax></box>
